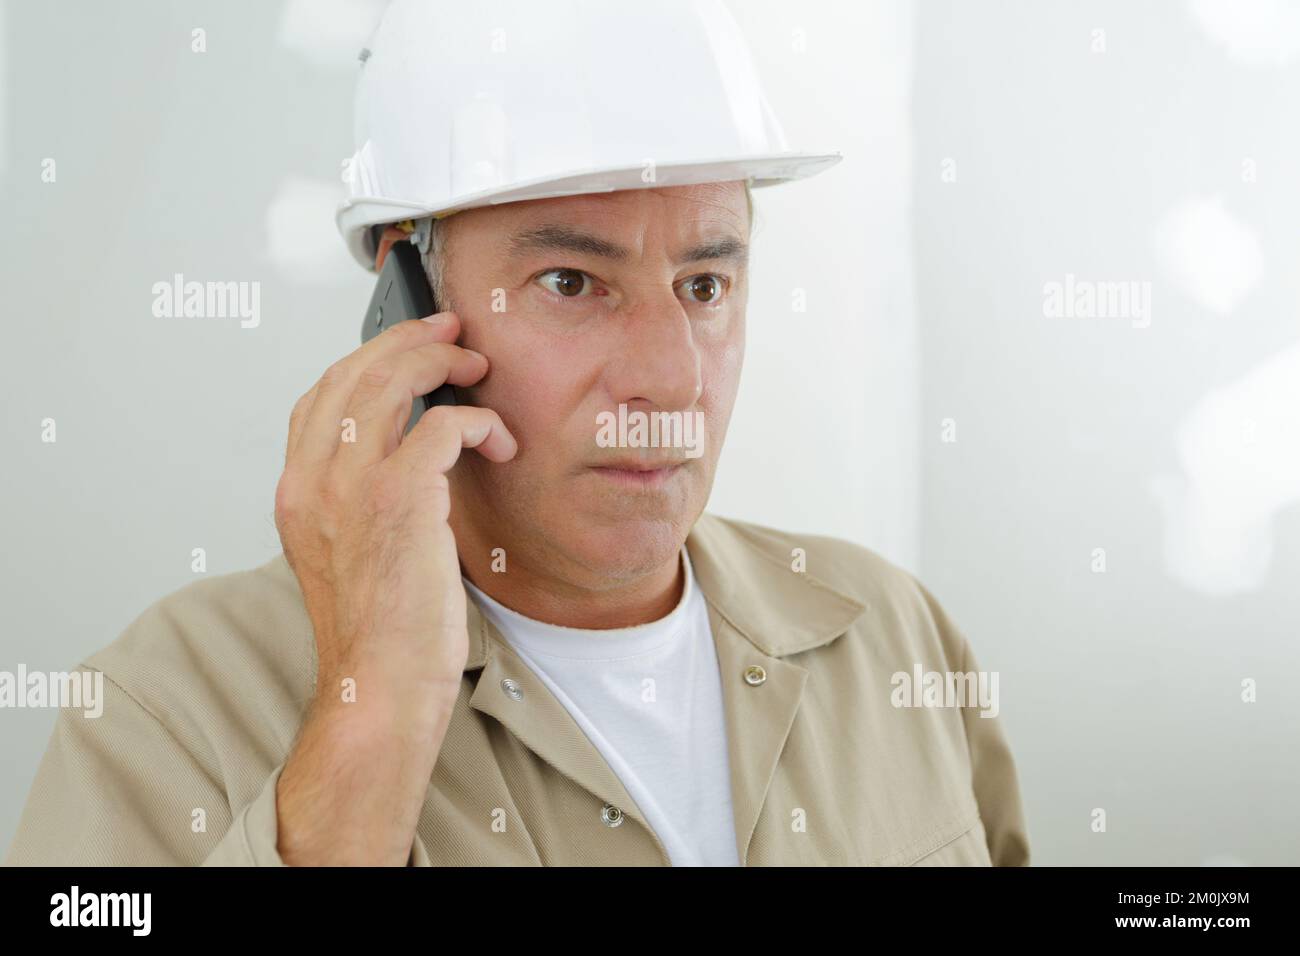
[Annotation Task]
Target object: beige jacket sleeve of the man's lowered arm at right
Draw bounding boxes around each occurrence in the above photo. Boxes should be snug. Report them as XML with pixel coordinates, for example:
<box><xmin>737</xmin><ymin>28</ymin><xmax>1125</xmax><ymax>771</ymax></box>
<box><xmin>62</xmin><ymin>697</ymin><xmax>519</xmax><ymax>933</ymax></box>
<box><xmin>917</xmin><ymin>581</ymin><xmax>1030</xmax><ymax>866</ymax></box>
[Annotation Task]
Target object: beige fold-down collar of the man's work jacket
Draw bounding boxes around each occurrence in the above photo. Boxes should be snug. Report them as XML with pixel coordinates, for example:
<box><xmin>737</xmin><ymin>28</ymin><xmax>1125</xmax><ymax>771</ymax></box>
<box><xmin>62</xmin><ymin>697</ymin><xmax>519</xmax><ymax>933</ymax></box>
<box><xmin>465</xmin><ymin>514</ymin><xmax>866</xmax><ymax>671</ymax></box>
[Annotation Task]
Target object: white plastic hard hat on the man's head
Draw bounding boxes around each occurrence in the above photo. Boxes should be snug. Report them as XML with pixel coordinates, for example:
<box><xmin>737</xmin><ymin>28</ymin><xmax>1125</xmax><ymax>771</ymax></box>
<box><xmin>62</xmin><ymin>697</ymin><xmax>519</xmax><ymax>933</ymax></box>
<box><xmin>335</xmin><ymin>0</ymin><xmax>841</xmax><ymax>269</ymax></box>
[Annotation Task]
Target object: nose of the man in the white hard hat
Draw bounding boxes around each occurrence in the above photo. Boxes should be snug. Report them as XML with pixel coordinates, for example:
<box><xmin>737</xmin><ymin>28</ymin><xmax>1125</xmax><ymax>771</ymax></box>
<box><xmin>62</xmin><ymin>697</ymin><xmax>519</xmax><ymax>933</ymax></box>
<box><xmin>606</xmin><ymin>290</ymin><xmax>703</xmax><ymax>411</ymax></box>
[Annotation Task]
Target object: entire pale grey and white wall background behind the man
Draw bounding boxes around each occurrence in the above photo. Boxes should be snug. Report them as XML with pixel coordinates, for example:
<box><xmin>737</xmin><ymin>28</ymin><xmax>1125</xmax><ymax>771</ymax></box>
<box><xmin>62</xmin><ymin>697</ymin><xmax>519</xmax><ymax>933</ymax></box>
<box><xmin>0</xmin><ymin>0</ymin><xmax>1300</xmax><ymax>865</ymax></box>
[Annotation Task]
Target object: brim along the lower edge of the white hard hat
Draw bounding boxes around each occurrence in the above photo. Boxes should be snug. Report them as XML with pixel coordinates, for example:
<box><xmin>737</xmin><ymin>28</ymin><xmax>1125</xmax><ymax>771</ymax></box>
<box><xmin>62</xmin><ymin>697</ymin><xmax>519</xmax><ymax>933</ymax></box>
<box><xmin>335</xmin><ymin>152</ymin><xmax>844</xmax><ymax>272</ymax></box>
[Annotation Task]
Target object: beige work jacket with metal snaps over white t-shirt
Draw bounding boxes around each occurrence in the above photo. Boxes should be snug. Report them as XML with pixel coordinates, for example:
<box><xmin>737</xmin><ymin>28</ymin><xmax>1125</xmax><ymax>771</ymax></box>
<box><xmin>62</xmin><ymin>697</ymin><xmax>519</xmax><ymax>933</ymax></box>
<box><xmin>7</xmin><ymin>514</ymin><xmax>1028</xmax><ymax>866</ymax></box>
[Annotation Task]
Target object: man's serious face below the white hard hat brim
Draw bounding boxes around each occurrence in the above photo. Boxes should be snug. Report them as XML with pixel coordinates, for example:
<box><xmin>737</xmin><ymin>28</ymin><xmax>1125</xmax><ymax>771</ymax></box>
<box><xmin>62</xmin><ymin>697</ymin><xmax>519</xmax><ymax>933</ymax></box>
<box><xmin>445</xmin><ymin>182</ymin><xmax>750</xmax><ymax>588</ymax></box>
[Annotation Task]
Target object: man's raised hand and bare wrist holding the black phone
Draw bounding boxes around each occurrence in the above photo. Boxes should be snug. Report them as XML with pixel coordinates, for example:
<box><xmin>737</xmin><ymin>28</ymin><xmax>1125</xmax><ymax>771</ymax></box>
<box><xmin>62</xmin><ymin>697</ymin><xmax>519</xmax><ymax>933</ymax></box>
<box><xmin>276</xmin><ymin>312</ymin><xmax>517</xmax><ymax>865</ymax></box>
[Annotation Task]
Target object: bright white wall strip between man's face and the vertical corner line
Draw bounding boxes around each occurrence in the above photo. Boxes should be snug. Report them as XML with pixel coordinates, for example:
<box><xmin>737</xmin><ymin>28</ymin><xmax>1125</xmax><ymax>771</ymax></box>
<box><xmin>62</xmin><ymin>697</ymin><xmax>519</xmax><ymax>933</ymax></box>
<box><xmin>710</xmin><ymin>0</ymin><xmax>920</xmax><ymax>568</ymax></box>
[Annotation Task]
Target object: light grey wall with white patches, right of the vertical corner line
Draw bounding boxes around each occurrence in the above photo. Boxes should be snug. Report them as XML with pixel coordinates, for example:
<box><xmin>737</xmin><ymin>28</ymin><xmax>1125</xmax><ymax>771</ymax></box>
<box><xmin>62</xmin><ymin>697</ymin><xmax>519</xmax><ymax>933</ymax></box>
<box><xmin>914</xmin><ymin>0</ymin><xmax>1300</xmax><ymax>865</ymax></box>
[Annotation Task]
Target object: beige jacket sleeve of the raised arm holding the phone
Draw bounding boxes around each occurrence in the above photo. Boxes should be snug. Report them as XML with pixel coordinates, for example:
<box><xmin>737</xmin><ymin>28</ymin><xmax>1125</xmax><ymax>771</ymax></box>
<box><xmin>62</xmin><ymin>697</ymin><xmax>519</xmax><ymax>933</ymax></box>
<box><xmin>5</xmin><ymin>666</ymin><xmax>430</xmax><ymax>866</ymax></box>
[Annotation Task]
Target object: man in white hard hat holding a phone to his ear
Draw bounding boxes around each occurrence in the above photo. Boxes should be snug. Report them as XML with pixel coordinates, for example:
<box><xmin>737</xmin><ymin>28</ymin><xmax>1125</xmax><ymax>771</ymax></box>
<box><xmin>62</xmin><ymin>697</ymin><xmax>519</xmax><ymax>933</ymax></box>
<box><xmin>9</xmin><ymin>3</ymin><xmax>1028</xmax><ymax>865</ymax></box>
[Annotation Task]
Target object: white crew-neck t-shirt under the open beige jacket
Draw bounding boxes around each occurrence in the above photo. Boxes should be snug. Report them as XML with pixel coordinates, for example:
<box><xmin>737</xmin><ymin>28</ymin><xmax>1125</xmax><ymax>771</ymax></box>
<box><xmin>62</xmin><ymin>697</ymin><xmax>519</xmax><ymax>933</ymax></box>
<box><xmin>463</xmin><ymin>548</ymin><xmax>740</xmax><ymax>866</ymax></box>
